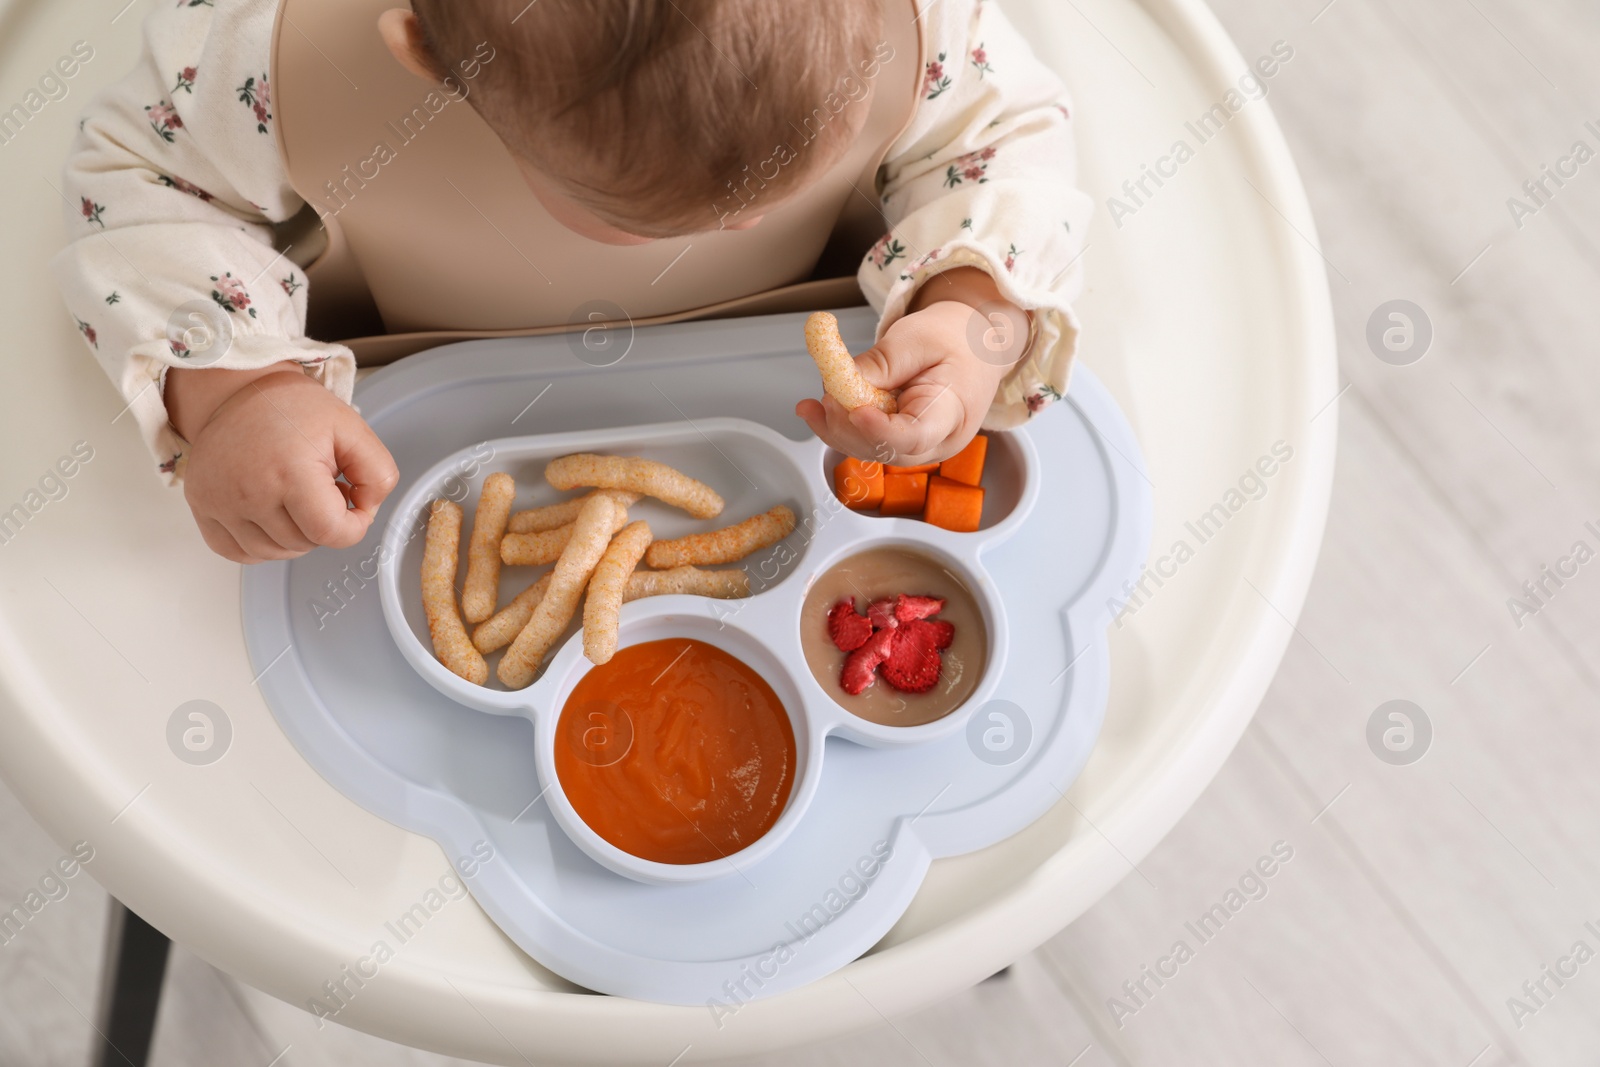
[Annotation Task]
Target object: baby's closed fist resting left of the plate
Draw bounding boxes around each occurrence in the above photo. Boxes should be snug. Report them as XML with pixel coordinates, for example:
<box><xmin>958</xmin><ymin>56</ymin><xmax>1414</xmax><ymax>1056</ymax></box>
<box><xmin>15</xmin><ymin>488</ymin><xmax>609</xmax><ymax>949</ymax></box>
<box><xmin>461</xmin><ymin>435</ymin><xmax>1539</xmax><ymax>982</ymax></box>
<box><xmin>166</xmin><ymin>365</ymin><xmax>400</xmax><ymax>563</ymax></box>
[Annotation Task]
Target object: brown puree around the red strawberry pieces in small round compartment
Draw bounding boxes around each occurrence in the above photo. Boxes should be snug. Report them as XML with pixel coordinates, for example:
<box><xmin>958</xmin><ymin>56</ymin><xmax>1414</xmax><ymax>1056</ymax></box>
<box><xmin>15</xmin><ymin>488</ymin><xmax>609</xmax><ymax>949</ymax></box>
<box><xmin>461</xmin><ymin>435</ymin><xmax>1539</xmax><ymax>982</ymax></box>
<box><xmin>800</xmin><ymin>549</ymin><xmax>989</xmax><ymax>726</ymax></box>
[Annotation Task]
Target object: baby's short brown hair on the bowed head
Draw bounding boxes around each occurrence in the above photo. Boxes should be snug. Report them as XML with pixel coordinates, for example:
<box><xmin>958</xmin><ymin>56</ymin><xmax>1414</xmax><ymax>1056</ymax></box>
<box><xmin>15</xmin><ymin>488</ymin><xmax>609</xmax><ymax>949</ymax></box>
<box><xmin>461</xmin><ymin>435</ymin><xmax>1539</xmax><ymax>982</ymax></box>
<box><xmin>413</xmin><ymin>0</ymin><xmax>886</xmax><ymax>237</ymax></box>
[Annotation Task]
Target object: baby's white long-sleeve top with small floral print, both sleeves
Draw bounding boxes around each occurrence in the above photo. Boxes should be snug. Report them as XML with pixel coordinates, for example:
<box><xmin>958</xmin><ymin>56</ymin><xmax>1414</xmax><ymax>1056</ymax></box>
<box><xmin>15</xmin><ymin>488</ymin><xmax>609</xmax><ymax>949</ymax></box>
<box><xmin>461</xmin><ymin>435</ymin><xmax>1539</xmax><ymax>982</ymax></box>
<box><xmin>53</xmin><ymin>0</ymin><xmax>1093</xmax><ymax>483</ymax></box>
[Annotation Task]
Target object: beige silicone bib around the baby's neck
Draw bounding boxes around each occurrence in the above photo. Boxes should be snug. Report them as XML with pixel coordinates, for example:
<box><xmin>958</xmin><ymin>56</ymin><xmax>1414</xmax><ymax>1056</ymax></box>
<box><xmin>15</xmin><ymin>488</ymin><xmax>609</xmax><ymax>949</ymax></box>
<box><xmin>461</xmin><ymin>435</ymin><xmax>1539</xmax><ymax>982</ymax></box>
<box><xmin>270</xmin><ymin>0</ymin><xmax>922</xmax><ymax>363</ymax></box>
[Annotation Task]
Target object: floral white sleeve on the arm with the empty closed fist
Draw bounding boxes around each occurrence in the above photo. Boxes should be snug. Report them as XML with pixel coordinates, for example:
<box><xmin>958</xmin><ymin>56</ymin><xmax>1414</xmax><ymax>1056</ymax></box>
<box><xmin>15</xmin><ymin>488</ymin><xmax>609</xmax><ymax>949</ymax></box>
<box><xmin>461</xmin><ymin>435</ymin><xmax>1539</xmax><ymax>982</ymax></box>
<box><xmin>51</xmin><ymin>0</ymin><xmax>355</xmax><ymax>485</ymax></box>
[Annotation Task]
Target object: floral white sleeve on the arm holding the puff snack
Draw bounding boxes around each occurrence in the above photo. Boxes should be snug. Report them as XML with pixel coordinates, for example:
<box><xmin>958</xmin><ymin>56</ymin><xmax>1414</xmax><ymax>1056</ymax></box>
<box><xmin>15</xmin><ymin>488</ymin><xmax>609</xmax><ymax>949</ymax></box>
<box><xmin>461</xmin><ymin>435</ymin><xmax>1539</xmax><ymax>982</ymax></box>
<box><xmin>856</xmin><ymin>0</ymin><xmax>1093</xmax><ymax>429</ymax></box>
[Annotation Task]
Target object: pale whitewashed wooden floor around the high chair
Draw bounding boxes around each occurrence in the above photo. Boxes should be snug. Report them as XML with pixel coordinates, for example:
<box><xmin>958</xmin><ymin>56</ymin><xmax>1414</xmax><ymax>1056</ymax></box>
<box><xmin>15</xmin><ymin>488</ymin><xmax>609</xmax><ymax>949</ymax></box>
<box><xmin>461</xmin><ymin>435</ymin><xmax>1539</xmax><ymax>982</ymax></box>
<box><xmin>0</xmin><ymin>0</ymin><xmax>1600</xmax><ymax>1067</ymax></box>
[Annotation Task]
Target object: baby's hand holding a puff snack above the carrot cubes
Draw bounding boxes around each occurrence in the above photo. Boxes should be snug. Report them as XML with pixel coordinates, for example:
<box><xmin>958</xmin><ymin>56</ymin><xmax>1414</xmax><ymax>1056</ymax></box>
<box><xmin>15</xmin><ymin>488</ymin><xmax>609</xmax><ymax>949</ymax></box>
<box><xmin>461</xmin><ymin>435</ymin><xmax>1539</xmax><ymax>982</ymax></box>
<box><xmin>795</xmin><ymin>267</ymin><xmax>1027</xmax><ymax>466</ymax></box>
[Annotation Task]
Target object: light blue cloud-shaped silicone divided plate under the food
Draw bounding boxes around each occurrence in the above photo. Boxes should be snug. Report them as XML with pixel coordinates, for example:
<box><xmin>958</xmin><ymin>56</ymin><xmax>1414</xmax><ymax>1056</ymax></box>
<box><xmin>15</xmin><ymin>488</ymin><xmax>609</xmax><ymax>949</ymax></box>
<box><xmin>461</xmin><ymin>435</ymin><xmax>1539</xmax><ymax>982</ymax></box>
<box><xmin>243</xmin><ymin>309</ymin><xmax>1150</xmax><ymax>1011</ymax></box>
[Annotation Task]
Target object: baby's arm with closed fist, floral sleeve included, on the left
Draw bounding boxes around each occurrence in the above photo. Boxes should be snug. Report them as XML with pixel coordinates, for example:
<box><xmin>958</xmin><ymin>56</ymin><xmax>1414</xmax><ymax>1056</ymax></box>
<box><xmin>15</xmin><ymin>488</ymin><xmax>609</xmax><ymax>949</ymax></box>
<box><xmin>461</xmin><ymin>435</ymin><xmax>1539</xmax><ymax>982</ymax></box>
<box><xmin>53</xmin><ymin>0</ymin><xmax>394</xmax><ymax>561</ymax></box>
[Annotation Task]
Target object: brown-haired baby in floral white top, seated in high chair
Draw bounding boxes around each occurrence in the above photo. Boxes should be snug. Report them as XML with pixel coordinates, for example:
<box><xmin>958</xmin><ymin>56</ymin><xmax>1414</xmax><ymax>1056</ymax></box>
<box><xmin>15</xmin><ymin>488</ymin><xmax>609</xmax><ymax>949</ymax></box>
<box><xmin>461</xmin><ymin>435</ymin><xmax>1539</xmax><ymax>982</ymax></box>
<box><xmin>53</xmin><ymin>0</ymin><xmax>1091</xmax><ymax>563</ymax></box>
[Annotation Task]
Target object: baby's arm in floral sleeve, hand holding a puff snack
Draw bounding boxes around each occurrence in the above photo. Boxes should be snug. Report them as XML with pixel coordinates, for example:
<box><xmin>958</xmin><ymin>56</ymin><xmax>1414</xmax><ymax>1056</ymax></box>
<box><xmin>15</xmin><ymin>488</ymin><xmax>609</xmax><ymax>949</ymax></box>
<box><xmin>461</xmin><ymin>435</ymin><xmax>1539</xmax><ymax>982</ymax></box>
<box><xmin>802</xmin><ymin>0</ymin><xmax>1093</xmax><ymax>461</ymax></box>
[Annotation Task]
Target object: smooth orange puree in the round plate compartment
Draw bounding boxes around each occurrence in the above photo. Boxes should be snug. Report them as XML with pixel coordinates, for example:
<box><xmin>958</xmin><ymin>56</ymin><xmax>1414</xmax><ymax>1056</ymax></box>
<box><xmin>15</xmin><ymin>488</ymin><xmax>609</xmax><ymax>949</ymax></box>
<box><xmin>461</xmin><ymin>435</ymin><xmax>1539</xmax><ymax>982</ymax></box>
<box><xmin>555</xmin><ymin>638</ymin><xmax>795</xmax><ymax>864</ymax></box>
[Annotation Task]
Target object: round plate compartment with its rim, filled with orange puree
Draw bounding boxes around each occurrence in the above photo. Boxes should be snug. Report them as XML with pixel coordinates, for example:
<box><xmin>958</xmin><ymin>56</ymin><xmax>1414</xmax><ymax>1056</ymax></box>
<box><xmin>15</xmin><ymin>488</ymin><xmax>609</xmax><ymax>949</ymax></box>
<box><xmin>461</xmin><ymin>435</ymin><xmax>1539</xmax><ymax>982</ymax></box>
<box><xmin>536</xmin><ymin>614</ymin><xmax>824</xmax><ymax>885</ymax></box>
